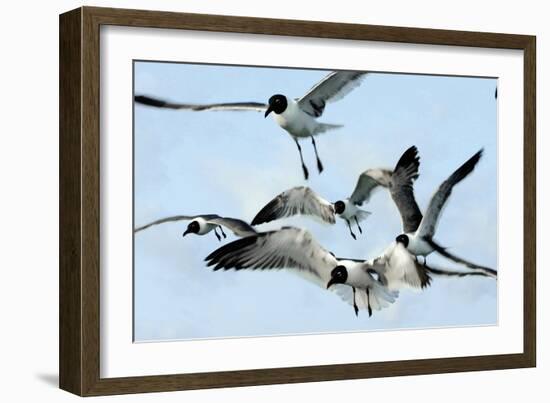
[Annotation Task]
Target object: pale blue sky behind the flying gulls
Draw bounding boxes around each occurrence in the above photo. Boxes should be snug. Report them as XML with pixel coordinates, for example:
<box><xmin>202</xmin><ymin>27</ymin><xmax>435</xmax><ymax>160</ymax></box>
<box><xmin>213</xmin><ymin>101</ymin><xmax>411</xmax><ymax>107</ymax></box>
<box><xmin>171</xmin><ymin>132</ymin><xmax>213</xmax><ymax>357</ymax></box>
<box><xmin>134</xmin><ymin>62</ymin><xmax>497</xmax><ymax>341</ymax></box>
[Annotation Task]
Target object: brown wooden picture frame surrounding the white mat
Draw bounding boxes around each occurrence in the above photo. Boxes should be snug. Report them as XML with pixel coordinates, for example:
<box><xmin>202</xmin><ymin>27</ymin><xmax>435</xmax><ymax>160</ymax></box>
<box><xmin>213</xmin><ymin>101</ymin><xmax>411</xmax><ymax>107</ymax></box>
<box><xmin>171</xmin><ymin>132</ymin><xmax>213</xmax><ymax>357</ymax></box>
<box><xmin>59</xmin><ymin>7</ymin><xmax>536</xmax><ymax>396</ymax></box>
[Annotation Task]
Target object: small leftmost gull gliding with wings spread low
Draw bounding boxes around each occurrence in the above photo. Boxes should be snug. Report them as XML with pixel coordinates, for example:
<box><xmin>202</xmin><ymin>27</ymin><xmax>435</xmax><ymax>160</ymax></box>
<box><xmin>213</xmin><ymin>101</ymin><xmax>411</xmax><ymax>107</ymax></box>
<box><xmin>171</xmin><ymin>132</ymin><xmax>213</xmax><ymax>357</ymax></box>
<box><xmin>134</xmin><ymin>214</ymin><xmax>256</xmax><ymax>242</ymax></box>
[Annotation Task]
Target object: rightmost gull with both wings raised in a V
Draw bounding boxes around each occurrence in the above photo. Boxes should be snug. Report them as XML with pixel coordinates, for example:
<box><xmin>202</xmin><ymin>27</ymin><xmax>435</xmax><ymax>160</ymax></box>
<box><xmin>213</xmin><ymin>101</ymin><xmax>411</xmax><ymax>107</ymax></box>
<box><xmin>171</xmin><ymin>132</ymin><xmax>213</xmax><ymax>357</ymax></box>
<box><xmin>392</xmin><ymin>149</ymin><xmax>496</xmax><ymax>275</ymax></box>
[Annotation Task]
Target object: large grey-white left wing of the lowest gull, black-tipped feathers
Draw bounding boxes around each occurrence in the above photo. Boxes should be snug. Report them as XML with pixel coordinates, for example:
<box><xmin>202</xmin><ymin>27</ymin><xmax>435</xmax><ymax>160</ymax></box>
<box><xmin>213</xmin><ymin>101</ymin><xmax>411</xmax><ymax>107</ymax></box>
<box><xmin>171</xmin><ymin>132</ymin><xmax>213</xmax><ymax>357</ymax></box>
<box><xmin>205</xmin><ymin>227</ymin><xmax>338</xmax><ymax>284</ymax></box>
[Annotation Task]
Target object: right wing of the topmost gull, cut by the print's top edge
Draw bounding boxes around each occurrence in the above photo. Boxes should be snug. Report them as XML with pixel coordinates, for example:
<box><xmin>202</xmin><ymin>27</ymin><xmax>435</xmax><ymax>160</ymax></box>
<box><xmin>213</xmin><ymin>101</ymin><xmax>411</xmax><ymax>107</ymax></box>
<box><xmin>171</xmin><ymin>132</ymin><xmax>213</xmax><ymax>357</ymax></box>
<box><xmin>298</xmin><ymin>71</ymin><xmax>366</xmax><ymax>117</ymax></box>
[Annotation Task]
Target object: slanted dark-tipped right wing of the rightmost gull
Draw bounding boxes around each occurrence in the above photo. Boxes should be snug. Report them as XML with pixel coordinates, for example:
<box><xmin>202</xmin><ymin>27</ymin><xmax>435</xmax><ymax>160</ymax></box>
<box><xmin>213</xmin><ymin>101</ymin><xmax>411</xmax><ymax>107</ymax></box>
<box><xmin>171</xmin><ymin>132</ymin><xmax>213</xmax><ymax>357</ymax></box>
<box><xmin>417</xmin><ymin>149</ymin><xmax>483</xmax><ymax>238</ymax></box>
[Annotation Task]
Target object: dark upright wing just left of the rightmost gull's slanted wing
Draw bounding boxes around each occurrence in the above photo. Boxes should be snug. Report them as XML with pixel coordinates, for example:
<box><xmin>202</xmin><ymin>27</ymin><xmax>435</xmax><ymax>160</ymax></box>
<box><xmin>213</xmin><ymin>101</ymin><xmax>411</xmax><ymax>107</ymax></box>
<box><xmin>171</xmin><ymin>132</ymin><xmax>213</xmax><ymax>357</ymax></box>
<box><xmin>390</xmin><ymin>146</ymin><xmax>422</xmax><ymax>233</ymax></box>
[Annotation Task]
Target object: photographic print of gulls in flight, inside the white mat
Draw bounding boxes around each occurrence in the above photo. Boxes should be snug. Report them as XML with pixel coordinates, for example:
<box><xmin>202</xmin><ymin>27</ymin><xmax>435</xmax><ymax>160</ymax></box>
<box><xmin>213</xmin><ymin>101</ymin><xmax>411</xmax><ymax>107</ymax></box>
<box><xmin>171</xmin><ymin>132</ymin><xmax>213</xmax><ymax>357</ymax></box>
<box><xmin>132</xmin><ymin>60</ymin><xmax>498</xmax><ymax>342</ymax></box>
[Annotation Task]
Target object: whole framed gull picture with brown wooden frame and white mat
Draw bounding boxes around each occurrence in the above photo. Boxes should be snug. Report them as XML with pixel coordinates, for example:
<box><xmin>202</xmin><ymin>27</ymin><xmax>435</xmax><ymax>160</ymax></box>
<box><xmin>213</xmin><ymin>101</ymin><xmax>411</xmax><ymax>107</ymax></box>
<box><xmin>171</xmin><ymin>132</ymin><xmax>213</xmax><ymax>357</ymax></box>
<box><xmin>60</xmin><ymin>7</ymin><xmax>536</xmax><ymax>396</ymax></box>
